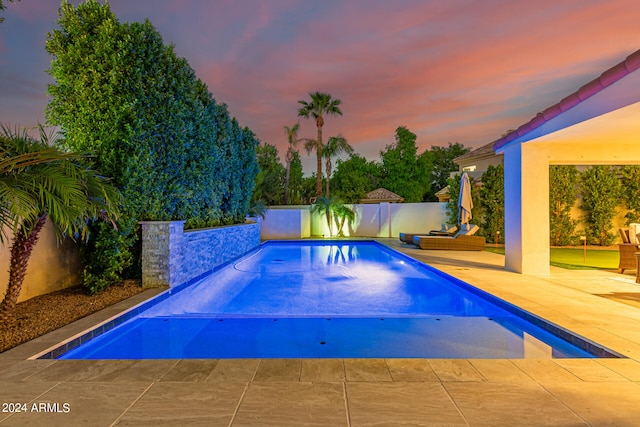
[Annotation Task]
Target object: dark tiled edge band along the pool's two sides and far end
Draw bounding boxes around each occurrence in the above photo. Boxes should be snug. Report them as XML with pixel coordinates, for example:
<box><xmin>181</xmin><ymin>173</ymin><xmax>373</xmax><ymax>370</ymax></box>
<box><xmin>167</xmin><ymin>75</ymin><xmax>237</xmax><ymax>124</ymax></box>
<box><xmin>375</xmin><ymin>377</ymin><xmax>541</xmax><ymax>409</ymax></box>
<box><xmin>21</xmin><ymin>239</ymin><xmax>627</xmax><ymax>360</ymax></box>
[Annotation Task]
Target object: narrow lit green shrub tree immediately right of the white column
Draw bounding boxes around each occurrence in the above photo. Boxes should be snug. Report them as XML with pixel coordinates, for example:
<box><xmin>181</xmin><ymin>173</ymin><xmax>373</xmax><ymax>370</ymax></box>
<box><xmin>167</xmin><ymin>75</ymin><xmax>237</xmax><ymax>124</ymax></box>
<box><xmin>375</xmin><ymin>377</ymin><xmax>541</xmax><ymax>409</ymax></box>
<box><xmin>549</xmin><ymin>165</ymin><xmax>580</xmax><ymax>246</ymax></box>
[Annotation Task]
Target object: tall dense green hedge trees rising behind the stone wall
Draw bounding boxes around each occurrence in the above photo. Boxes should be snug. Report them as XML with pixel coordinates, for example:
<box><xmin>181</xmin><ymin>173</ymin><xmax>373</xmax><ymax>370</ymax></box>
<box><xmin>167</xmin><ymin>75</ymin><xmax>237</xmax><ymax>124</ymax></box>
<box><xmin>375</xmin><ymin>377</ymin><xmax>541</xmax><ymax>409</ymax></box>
<box><xmin>46</xmin><ymin>0</ymin><xmax>258</xmax><ymax>289</ymax></box>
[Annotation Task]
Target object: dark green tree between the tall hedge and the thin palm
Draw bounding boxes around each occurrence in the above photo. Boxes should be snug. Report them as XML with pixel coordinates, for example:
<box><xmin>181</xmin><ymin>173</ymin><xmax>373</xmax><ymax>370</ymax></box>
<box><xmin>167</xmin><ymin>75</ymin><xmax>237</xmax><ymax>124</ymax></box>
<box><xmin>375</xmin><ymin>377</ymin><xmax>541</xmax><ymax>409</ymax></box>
<box><xmin>252</xmin><ymin>142</ymin><xmax>285</xmax><ymax>205</ymax></box>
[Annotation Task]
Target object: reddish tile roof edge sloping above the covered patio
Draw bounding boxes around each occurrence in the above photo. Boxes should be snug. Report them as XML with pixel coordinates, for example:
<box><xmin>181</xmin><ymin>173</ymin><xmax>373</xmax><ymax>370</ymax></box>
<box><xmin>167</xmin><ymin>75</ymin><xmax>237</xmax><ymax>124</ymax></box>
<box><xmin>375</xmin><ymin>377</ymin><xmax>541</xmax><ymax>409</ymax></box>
<box><xmin>492</xmin><ymin>50</ymin><xmax>640</xmax><ymax>154</ymax></box>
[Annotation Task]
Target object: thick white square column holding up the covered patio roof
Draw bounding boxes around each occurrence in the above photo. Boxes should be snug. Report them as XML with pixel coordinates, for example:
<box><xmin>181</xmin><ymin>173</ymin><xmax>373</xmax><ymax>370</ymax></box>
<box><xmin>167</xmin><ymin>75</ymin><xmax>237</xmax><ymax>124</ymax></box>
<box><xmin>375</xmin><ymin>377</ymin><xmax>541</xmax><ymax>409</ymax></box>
<box><xmin>504</xmin><ymin>143</ymin><xmax>550</xmax><ymax>275</ymax></box>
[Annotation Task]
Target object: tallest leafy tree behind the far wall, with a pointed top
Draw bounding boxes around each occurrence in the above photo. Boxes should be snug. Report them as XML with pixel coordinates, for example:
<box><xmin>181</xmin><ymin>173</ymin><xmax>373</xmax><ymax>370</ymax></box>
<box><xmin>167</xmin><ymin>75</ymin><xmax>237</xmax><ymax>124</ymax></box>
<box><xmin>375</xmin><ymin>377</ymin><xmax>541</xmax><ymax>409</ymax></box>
<box><xmin>380</xmin><ymin>126</ymin><xmax>432</xmax><ymax>202</ymax></box>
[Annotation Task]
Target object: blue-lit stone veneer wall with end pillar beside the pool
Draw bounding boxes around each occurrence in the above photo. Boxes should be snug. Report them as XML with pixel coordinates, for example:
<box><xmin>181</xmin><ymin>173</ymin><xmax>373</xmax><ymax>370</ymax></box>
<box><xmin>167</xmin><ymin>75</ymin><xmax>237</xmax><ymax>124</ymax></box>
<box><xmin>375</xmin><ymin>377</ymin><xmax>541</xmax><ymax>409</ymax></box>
<box><xmin>140</xmin><ymin>221</ymin><xmax>260</xmax><ymax>287</ymax></box>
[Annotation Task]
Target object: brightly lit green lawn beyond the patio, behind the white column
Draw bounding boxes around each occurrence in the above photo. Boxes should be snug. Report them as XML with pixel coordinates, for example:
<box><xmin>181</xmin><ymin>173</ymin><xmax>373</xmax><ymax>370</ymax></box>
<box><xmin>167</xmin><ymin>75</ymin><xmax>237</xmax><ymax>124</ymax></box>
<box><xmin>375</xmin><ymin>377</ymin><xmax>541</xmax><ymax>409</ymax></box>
<box><xmin>486</xmin><ymin>245</ymin><xmax>620</xmax><ymax>270</ymax></box>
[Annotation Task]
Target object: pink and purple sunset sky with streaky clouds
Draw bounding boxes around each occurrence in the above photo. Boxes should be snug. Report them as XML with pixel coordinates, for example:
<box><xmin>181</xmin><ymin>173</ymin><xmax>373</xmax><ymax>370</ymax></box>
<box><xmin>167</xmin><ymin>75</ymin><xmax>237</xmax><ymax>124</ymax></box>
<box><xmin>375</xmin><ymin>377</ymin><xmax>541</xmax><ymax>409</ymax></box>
<box><xmin>0</xmin><ymin>0</ymin><xmax>640</xmax><ymax>174</ymax></box>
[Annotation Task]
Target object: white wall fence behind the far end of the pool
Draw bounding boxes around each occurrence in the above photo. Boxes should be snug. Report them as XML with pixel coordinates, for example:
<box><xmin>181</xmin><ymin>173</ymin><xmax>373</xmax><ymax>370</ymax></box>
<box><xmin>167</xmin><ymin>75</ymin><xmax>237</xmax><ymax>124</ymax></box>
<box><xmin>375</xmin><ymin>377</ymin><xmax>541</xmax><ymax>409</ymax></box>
<box><xmin>260</xmin><ymin>202</ymin><xmax>447</xmax><ymax>240</ymax></box>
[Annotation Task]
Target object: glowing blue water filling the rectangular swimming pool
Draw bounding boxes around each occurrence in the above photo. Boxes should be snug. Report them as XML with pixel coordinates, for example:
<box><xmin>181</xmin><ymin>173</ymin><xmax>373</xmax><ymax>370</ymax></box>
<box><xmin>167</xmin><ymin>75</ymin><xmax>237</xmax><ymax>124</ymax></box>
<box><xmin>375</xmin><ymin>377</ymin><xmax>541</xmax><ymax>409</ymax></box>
<box><xmin>61</xmin><ymin>241</ymin><xmax>608</xmax><ymax>359</ymax></box>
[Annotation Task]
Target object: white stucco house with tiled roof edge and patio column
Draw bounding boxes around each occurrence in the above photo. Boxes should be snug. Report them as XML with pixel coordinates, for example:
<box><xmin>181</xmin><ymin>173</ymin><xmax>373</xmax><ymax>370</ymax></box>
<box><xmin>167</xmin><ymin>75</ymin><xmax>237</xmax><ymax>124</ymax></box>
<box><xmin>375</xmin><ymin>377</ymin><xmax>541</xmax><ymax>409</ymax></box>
<box><xmin>490</xmin><ymin>50</ymin><xmax>640</xmax><ymax>275</ymax></box>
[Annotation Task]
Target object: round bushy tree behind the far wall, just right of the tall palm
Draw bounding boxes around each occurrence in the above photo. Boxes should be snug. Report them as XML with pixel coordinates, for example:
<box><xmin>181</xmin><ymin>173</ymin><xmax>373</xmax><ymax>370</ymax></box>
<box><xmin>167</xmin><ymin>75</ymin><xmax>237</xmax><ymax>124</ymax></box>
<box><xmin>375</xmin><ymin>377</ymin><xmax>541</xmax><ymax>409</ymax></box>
<box><xmin>331</xmin><ymin>154</ymin><xmax>382</xmax><ymax>203</ymax></box>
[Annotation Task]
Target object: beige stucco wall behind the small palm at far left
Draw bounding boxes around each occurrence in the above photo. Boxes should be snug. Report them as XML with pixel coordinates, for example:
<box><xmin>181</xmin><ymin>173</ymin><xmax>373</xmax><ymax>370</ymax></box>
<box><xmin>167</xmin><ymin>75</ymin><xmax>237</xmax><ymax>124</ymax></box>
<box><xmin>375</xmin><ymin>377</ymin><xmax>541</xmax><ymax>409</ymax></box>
<box><xmin>0</xmin><ymin>221</ymin><xmax>82</xmax><ymax>302</ymax></box>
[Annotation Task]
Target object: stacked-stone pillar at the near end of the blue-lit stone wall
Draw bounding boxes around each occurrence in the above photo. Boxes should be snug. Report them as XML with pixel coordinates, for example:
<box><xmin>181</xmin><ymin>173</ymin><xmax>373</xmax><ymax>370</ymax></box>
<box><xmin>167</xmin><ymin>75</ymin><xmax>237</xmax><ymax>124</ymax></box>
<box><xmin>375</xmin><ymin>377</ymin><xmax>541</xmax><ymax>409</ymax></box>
<box><xmin>140</xmin><ymin>221</ymin><xmax>185</xmax><ymax>288</ymax></box>
